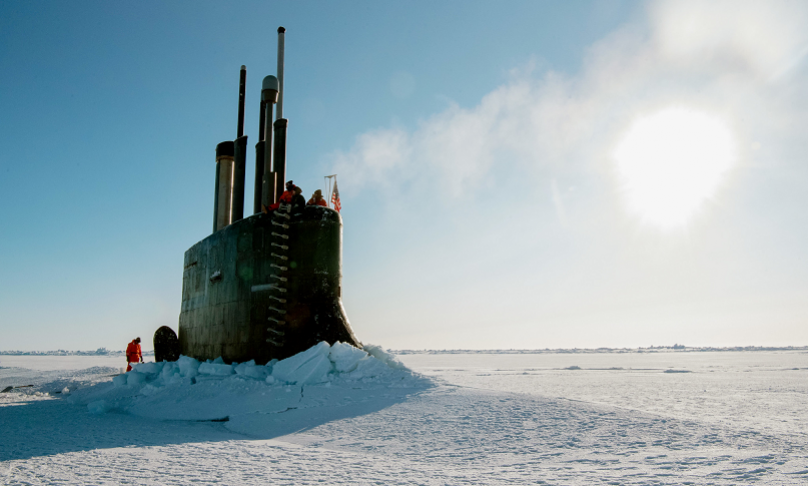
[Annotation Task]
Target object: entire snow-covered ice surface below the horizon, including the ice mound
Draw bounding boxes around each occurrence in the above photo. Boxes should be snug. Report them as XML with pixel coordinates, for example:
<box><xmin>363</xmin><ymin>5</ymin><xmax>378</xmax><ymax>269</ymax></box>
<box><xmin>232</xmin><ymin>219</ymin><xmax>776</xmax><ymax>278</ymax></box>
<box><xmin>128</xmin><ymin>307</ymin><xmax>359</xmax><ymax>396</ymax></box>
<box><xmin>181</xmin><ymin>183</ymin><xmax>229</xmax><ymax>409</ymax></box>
<box><xmin>0</xmin><ymin>343</ymin><xmax>808</xmax><ymax>485</ymax></box>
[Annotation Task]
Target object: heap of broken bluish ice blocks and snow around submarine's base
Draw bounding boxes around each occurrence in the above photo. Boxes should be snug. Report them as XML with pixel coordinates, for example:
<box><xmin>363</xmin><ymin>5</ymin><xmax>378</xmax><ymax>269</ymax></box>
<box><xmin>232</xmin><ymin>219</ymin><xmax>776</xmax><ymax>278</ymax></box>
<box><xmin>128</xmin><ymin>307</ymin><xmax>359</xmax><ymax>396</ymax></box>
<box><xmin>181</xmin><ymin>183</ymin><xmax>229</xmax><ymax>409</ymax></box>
<box><xmin>68</xmin><ymin>341</ymin><xmax>431</xmax><ymax>420</ymax></box>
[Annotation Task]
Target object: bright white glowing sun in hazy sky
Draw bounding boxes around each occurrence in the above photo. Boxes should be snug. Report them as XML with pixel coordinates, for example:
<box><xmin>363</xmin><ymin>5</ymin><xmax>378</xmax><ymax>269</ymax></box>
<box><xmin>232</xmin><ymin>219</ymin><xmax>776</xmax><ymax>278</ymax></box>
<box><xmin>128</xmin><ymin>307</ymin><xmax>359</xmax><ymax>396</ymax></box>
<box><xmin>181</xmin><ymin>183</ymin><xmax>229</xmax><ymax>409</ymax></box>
<box><xmin>614</xmin><ymin>108</ymin><xmax>735</xmax><ymax>229</ymax></box>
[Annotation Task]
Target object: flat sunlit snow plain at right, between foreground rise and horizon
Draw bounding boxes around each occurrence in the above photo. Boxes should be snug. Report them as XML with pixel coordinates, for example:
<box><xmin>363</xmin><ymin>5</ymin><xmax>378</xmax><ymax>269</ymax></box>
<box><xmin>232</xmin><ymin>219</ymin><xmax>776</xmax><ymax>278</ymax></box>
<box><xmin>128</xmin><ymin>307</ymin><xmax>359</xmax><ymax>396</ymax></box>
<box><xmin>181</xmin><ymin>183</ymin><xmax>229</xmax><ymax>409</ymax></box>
<box><xmin>400</xmin><ymin>351</ymin><xmax>808</xmax><ymax>437</ymax></box>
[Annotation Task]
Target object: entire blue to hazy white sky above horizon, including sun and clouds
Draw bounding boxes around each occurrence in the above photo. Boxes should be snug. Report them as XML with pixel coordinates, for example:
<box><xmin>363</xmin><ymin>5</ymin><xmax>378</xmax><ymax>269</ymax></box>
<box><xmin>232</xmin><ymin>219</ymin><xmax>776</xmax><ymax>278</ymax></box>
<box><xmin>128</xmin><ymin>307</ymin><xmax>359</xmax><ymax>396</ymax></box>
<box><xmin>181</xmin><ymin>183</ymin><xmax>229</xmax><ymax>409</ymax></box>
<box><xmin>0</xmin><ymin>0</ymin><xmax>808</xmax><ymax>350</ymax></box>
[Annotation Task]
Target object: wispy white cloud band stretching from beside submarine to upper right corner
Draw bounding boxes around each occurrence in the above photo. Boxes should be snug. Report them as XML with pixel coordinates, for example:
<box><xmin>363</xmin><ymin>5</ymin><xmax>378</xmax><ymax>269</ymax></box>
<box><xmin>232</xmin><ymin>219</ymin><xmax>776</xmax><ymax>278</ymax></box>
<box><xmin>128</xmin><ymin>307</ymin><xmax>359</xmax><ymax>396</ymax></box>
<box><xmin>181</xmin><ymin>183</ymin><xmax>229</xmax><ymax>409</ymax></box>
<box><xmin>332</xmin><ymin>1</ymin><xmax>808</xmax><ymax>209</ymax></box>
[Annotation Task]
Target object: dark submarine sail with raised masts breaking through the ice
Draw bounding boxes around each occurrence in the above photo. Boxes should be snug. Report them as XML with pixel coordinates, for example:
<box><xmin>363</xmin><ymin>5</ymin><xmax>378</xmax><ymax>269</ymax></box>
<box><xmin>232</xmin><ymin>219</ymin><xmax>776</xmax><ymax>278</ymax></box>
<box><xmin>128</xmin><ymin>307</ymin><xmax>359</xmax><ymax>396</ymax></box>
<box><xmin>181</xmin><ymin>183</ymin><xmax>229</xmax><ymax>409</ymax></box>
<box><xmin>154</xmin><ymin>27</ymin><xmax>362</xmax><ymax>364</ymax></box>
